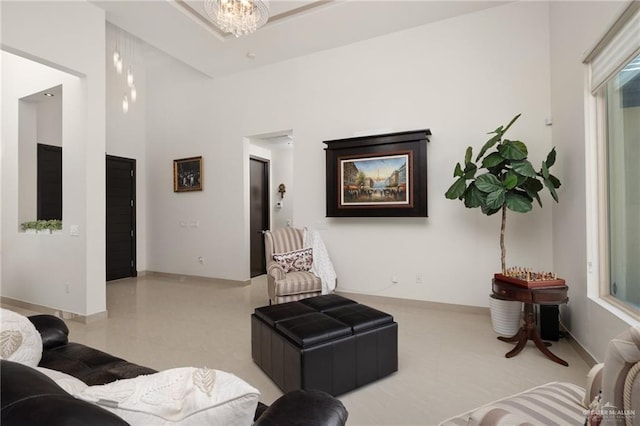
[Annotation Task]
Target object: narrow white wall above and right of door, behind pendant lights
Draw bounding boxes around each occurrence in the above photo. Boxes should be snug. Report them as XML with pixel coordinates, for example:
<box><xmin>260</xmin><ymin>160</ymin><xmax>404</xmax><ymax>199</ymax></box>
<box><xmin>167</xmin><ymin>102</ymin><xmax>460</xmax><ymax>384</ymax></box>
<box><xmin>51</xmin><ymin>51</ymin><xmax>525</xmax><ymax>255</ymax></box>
<box><xmin>105</xmin><ymin>25</ymin><xmax>149</xmax><ymax>271</ymax></box>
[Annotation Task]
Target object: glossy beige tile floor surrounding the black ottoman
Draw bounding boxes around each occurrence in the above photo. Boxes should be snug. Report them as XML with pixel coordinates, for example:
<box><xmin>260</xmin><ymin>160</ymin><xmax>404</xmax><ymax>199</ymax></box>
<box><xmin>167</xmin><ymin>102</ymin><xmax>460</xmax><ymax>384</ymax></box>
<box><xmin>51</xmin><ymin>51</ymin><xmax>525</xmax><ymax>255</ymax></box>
<box><xmin>7</xmin><ymin>275</ymin><xmax>589</xmax><ymax>425</ymax></box>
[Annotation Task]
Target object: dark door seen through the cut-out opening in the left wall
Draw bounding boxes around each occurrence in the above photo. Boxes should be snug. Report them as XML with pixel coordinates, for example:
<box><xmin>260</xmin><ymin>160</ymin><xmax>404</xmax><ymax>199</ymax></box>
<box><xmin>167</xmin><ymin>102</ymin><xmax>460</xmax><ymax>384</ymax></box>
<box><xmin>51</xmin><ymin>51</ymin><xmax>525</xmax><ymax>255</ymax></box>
<box><xmin>37</xmin><ymin>143</ymin><xmax>62</xmax><ymax>220</ymax></box>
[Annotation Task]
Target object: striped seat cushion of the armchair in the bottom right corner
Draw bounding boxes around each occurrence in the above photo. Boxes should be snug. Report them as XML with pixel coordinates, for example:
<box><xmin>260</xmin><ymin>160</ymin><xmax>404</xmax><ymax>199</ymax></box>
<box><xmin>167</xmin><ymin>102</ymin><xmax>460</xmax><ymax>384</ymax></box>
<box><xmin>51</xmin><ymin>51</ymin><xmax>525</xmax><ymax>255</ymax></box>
<box><xmin>441</xmin><ymin>382</ymin><xmax>586</xmax><ymax>426</ymax></box>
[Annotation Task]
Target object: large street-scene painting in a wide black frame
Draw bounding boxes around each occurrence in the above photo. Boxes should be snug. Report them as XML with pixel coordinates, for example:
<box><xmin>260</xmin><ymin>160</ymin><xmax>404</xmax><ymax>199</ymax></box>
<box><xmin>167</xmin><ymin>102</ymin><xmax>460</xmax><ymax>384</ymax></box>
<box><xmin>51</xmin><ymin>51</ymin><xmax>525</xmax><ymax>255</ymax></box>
<box><xmin>324</xmin><ymin>129</ymin><xmax>431</xmax><ymax>217</ymax></box>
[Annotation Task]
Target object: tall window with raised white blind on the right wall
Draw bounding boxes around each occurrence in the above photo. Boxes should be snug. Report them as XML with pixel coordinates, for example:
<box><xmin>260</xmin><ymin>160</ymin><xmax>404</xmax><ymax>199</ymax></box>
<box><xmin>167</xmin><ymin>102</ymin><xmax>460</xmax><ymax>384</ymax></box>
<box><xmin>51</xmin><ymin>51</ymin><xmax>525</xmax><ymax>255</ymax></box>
<box><xmin>585</xmin><ymin>1</ymin><xmax>640</xmax><ymax>317</ymax></box>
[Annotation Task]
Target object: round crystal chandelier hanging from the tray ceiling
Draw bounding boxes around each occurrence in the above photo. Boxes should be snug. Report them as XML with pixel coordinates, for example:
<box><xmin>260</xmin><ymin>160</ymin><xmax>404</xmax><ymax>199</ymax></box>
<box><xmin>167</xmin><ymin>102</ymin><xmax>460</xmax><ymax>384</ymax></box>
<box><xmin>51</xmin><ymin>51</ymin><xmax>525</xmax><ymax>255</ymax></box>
<box><xmin>204</xmin><ymin>0</ymin><xmax>269</xmax><ymax>37</ymax></box>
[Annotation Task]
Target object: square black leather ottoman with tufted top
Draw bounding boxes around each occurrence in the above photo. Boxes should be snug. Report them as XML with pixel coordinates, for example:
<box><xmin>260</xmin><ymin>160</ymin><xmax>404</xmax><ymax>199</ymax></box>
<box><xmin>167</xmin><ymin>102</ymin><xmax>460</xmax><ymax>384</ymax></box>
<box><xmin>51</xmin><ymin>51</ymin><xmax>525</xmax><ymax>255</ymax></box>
<box><xmin>251</xmin><ymin>294</ymin><xmax>398</xmax><ymax>396</ymax></box>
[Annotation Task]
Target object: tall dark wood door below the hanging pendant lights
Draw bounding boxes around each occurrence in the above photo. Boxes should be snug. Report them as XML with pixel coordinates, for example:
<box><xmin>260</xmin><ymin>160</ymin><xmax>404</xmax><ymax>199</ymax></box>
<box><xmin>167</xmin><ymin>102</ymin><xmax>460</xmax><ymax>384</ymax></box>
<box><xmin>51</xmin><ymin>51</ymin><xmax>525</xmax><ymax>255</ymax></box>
<box><xmin>106</xmin><ymin>155</ymin><xmax>137</xmax><ymax>281</ymax></box>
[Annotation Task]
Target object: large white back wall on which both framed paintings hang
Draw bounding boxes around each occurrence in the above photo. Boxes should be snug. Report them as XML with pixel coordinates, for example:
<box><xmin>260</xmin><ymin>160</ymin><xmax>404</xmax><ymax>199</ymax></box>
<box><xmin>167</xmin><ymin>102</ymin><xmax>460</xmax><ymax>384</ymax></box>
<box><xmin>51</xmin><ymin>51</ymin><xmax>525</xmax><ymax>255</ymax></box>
<box><xmin>148</xmin><ymin>2</ymin><xmax>553</xmax><ymax>306</ymax></box>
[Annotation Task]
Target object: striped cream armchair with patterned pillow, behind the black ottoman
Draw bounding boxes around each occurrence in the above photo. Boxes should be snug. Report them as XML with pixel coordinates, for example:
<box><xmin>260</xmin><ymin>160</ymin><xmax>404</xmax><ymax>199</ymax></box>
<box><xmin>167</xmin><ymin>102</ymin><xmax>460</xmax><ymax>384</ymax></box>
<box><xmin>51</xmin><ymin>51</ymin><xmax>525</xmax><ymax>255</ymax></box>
<box><xmin>264</xmin><ymin>228</ymin><xmax>322</xmax><ymax>304</ymax></box>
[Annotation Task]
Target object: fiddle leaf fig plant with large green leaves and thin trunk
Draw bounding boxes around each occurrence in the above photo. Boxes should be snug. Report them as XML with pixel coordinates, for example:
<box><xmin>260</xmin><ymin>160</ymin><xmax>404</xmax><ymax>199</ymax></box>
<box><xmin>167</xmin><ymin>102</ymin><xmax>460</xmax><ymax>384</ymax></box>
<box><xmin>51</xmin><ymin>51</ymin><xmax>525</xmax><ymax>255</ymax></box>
<box><xmin>445</xmin><ymin>114</ymin><xmax>561</xmax><ymax>273</ymax></box>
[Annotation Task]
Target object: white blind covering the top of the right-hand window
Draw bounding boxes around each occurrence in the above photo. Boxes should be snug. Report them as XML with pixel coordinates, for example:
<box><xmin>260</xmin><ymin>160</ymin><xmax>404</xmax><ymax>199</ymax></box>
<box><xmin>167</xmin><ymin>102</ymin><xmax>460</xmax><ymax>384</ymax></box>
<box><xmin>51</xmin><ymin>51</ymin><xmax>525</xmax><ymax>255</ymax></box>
<box><xmin>584</xmin><ymin>1</ymin><xmax>640</xmax><ymax>94</ymax></box>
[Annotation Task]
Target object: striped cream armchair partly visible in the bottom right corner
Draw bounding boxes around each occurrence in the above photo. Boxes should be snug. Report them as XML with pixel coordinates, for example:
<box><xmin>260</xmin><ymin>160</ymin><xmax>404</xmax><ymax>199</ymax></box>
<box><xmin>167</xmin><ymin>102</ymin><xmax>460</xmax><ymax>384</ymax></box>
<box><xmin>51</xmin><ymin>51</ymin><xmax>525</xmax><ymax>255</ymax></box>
<box><xmin>440</xmin><ymin>325</ymin><xmax>640</xmax><ymax>426</ymax></box>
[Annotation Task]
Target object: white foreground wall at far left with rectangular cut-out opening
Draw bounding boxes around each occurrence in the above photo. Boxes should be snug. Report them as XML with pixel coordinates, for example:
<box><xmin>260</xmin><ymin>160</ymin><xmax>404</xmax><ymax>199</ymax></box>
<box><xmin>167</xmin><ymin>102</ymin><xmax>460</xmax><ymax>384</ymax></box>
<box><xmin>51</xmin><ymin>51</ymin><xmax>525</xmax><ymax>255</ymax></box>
<box><xmin>1</xmin><ymin>2</ymin><xmax>106</xmax><ymax>315</ymax></box>
